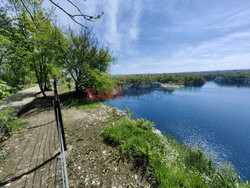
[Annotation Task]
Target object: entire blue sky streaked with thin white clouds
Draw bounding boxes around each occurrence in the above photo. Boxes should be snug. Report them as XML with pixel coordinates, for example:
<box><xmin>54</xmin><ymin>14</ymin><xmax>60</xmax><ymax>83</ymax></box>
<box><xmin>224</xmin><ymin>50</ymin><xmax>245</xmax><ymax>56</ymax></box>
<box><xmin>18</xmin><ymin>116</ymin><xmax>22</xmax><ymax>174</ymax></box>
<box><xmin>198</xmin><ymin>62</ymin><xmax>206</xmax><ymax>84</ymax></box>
<box><xmin>48</xmin><ymin>0</ymin><xmax>250</xmax><ymax>74</ymax></box>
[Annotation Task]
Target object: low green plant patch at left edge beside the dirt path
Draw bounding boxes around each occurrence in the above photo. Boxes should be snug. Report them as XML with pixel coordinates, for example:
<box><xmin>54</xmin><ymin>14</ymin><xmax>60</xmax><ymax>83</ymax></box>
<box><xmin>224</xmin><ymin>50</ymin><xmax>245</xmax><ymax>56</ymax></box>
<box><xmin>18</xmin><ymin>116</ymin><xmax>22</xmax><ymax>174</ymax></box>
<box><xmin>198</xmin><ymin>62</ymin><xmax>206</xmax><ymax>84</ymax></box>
<box><xmin>0</xmin><ymin>110</ymin><xmax>27</xmax><ymax>141</ymax></box>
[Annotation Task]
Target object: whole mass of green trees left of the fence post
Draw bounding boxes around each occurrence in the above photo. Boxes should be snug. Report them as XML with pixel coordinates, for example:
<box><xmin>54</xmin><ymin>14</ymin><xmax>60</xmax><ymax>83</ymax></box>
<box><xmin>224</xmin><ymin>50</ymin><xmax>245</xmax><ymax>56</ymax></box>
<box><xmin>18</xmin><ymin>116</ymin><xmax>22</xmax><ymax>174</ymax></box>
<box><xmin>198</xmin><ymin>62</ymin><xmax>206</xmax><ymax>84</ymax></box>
<box><xmin>0</xmin><ymin>0</ymin><xmax>64</xmax><ymax>96</ymax></box>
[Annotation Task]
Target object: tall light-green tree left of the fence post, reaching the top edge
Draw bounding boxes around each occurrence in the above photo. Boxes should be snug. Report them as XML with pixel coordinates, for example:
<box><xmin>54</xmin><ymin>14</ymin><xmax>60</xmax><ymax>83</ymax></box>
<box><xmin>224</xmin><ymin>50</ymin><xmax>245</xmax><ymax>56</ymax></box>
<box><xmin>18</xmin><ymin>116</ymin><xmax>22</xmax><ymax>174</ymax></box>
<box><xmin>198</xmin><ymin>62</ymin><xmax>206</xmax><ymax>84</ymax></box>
<box><xmin>7</xmin><ymin>0</ymin><xmax>64</xmax><ymax>96</ymax></box>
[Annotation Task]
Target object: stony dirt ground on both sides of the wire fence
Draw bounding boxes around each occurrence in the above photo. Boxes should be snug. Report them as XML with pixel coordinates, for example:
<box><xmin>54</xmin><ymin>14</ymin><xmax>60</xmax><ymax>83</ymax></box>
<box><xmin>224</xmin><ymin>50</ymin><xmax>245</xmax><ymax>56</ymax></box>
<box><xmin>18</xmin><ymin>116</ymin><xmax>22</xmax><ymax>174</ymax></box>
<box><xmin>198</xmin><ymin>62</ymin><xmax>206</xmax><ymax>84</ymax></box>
<box><xmin>0</xmin><ymin>94</ymin><xmax>149</xmax><ymax>188</ymax></box>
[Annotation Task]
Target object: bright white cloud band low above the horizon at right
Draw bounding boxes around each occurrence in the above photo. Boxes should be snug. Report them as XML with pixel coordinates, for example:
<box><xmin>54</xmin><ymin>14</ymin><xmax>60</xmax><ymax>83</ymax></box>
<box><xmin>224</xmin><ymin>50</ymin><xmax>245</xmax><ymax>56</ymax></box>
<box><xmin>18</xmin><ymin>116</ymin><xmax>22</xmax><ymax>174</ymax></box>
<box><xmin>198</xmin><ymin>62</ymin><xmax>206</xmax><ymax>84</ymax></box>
<box><xmin>114</xmin><ymin>31</ymin><xmax>250</xmax><ymax>74</ymax></box>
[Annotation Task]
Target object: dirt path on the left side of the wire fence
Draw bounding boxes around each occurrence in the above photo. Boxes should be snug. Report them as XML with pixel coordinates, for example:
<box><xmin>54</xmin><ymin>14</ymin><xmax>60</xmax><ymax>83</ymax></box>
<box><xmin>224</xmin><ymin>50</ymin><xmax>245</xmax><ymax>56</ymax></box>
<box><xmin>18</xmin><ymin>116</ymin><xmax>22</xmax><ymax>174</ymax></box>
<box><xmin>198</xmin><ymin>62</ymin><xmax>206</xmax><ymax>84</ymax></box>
<box><xmin>0</xmin><ymin>99</ymin><xmax>61</xmax><ymax>187</ymax></box>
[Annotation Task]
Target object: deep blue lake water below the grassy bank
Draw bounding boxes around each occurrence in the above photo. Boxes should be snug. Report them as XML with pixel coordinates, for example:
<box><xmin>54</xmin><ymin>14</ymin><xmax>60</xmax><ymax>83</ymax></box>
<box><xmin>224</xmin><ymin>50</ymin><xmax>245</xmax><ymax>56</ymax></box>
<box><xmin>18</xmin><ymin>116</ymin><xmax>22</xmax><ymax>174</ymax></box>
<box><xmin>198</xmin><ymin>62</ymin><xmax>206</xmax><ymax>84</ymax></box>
<box><xmin>104</xmin><ymin>82</ymin><xmax>250</xmax><ymax>180</ymax></box>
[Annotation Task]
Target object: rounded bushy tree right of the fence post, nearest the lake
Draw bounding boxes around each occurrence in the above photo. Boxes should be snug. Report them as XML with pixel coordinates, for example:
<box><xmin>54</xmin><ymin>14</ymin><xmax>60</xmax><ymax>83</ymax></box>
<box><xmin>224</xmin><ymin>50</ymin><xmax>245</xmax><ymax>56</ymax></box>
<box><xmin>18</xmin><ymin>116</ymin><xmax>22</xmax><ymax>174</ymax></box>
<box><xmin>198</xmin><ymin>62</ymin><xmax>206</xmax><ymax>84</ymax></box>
<box><xmin>64</xmin><ymin>31</ymin><xmax>115</xmax><ymax>93</ymax></box>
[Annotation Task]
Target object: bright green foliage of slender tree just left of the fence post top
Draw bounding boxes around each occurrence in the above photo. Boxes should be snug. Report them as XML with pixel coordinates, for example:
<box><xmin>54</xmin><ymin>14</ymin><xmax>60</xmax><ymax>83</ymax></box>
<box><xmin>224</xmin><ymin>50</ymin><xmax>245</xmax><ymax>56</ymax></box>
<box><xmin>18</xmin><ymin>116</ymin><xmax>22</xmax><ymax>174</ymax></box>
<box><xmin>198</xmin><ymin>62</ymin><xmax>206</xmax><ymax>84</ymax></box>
<box><xmin>23</xmin><ymin>3</ymin><xmax>65</xmax><ymax>96</ymax></box>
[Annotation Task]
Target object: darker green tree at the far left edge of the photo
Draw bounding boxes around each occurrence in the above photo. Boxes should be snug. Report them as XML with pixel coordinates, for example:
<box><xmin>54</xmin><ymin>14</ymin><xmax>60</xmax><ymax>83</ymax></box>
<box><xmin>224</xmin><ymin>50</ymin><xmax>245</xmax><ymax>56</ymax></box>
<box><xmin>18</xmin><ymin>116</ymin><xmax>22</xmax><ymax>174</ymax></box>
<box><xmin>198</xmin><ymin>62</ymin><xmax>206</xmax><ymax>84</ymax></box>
<box><xmin>0</xmin><ymin>11</ymin><xmax>31</xmax><ymax>87</ymax></box>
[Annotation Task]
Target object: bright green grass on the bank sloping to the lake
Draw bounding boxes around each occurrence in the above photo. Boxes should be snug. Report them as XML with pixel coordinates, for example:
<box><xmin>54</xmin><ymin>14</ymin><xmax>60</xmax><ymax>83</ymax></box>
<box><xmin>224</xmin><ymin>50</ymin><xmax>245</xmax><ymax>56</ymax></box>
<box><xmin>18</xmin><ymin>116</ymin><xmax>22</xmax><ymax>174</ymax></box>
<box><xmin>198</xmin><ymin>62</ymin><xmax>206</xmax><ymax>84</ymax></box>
<box><xmin>102</xmin><ymin>117</ymin><xmax>250</xmax><ymax>187</ymax></box>
